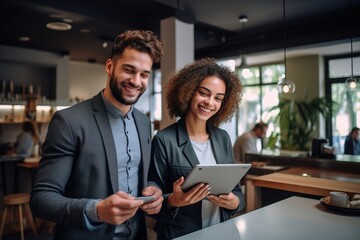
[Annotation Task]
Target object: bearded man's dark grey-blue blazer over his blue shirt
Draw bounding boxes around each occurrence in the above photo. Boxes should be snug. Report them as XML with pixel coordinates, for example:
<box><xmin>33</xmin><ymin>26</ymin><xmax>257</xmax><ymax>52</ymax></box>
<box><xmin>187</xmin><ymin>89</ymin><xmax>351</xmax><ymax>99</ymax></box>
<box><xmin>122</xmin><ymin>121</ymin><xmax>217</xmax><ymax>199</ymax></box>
<box><xmin>31</xmin><ymin>93</ymin><xmax>151</xmax><ymax>240</ymax></box>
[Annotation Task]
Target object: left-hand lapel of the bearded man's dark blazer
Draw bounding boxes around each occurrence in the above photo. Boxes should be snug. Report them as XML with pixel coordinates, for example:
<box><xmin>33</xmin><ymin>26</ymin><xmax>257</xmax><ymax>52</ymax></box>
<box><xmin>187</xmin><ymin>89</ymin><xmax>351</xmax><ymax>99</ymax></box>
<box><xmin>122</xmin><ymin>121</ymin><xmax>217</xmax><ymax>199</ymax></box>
<box><xmin>93</xmin><ymin>93</ymin><xmax>119</xmax><ymax>193</ymax></box>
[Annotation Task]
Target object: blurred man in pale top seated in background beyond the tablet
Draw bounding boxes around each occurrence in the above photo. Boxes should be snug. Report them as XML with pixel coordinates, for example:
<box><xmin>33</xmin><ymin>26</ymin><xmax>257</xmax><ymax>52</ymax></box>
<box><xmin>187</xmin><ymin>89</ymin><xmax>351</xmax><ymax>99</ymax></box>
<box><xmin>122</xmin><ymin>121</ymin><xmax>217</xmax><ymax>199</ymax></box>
<box><xmin>233</xmin><ymin>122</ymin><xmax>268</xmax><ymax>163</ymax></box>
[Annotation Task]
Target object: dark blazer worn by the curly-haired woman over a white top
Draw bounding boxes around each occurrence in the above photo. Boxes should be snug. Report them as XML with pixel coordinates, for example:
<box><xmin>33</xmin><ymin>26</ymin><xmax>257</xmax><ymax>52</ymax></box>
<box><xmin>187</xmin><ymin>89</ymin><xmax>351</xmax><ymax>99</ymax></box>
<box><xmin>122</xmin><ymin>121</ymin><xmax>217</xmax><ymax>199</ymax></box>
<box><xmin>149</xmin><ymin>119</ymin><xmax>245</xmax><ymax>239</ymax></box>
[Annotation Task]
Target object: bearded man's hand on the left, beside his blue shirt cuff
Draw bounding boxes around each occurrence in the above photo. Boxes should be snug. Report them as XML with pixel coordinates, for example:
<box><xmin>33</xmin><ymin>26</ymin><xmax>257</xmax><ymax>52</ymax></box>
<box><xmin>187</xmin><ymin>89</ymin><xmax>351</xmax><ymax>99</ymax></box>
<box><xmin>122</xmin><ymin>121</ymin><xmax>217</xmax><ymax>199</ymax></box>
<box><xmin>96</xmin><ymin>191</ymin><xmax>143</xmax><ymax>225</ymax></box>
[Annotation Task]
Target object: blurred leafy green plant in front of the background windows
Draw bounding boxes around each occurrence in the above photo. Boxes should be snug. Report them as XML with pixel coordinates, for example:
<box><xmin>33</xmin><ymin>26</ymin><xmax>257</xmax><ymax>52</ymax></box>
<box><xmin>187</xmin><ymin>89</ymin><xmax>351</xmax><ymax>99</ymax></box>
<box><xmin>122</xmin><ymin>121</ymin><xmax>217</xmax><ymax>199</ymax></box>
<box><xmin>270</xmin><ymin>97</ymin><xmax>337</xmax><ymax>151</ymax></box>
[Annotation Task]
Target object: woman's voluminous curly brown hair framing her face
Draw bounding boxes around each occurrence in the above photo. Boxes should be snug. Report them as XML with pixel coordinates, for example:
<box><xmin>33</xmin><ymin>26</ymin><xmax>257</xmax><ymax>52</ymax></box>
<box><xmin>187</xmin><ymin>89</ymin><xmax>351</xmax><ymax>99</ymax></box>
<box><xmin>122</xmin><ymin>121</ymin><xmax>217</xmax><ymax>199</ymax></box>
<box><xmin>166</xmin><ymin>58</ymin><xmax>242</xmax><ymax>126</ymax></box>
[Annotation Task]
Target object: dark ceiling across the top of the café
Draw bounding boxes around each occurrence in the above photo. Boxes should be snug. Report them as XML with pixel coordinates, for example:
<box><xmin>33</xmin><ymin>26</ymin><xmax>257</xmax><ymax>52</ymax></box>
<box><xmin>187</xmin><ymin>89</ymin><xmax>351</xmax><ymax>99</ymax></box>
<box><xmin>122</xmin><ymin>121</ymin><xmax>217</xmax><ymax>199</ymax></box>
<box><xmin>0</xmin><ymin>0</ymin><xmax>360</xmax><ymax>63</ymax></box>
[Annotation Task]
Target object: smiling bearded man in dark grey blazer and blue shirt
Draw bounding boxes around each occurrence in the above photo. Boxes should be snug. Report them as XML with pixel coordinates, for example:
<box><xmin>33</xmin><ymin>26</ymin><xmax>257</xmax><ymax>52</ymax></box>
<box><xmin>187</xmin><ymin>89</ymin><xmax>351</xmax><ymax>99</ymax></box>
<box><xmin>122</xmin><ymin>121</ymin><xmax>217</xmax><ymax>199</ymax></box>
<box><xmin>30</xmin><ymin>31</ymin><xmax>163</xmax><ymax>240</ymax></box>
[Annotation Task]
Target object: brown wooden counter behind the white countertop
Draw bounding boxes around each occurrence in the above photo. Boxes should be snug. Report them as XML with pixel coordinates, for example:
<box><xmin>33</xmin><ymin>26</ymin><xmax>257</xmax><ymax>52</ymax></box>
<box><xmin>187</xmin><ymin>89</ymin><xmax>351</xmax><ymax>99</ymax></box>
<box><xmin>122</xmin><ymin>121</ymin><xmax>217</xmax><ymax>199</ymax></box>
<box><xmin>245</xmin><ymin>153</ymin><xmax>360</xmax><ymax>212</ymax></box>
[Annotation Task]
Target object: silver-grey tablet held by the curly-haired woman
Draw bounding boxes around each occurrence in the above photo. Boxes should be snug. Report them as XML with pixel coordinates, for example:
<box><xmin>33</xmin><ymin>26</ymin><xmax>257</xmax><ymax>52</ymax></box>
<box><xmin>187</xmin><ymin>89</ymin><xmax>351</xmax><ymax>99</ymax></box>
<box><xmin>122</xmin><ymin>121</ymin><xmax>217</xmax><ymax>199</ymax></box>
<box><xmin>181</xmin><ymin>163</ymin><xmax>251</xmax><ymax>195</ymax></box>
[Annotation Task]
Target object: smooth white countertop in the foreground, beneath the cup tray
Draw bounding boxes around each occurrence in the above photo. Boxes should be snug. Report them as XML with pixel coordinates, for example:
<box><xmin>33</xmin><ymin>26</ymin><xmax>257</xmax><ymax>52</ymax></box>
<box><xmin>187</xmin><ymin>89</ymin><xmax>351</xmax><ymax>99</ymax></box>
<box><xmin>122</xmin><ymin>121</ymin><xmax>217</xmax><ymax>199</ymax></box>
<box><xmin>176</xmin><ymin>197</ymin><xmax>360</xmax><ymax>240</ymax></box>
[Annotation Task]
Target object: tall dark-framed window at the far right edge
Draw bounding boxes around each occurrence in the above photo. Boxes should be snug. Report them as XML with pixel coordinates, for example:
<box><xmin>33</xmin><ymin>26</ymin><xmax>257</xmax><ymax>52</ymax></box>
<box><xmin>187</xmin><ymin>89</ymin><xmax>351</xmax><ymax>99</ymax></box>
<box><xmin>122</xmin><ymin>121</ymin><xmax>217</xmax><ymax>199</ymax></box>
<box><xmin>325</xmin><ymin>54</ymin><xmax>360</xmax><ymax>154</ymax></box>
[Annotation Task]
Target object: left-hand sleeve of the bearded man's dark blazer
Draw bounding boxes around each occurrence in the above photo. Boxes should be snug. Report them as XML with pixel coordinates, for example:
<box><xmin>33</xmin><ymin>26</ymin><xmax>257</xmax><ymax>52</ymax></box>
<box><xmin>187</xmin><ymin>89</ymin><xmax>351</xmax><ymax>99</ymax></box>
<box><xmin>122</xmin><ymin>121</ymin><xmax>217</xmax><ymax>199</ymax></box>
<box><xmin>30</xmin><ymin>111</ymin><xmax>87</xmax><ymax>227</ymax></box>
